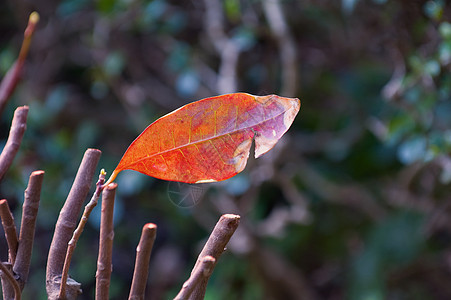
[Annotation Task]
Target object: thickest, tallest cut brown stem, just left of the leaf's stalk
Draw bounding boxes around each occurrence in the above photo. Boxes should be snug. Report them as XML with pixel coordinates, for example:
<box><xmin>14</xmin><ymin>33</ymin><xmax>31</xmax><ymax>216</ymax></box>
<box><xmin>46</xmin><ymin>149</ymin><xmax>102</xmax><ymax>299</ymax></box>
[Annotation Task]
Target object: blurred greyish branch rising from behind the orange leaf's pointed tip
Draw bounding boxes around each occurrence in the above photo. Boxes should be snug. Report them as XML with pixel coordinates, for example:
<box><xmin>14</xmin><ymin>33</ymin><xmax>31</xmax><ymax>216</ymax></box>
<box><xmin>263</xmin><ymin>0</ymin><xmax>298</xmax><ymax>96</ymax></box>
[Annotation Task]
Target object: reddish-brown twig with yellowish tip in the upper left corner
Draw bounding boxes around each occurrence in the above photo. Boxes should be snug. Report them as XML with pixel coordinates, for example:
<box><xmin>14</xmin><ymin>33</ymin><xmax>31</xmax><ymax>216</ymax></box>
<box><xmin>0</xmin><ymin>12</ymin><xmax>39</xmax><ymax>114</ymax></box>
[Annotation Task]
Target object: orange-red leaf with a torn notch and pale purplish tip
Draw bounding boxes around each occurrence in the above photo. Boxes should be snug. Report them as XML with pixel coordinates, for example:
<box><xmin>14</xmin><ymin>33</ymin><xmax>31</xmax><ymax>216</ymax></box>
<box><xmin>107</xmin><ymin>93</ymin><xmax>300</xmax><ymax>183</ymax></box>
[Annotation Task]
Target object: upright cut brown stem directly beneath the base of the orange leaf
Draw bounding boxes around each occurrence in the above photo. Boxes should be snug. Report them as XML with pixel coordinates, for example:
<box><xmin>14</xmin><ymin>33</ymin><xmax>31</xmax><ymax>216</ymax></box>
<box><xmin>96</xmin><ymin>183</ymin><xmax>117</xmax><ymax>300</ymax></box>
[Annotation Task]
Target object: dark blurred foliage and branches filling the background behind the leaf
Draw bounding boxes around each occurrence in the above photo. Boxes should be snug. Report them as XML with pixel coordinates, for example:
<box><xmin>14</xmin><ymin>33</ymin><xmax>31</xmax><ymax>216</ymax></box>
<box><xmin>0</xmin><ymin>0</ymin><xmax>451</xmax><ymax>300</ymax></box>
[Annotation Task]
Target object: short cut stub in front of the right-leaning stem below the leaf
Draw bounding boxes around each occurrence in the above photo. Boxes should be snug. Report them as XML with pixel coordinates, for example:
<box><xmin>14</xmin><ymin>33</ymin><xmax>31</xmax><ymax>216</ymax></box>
<box><xmin>174</xmin><ymin>255</ymin><xmax>216</xmax><ymax>300</ymax></box>
